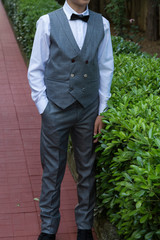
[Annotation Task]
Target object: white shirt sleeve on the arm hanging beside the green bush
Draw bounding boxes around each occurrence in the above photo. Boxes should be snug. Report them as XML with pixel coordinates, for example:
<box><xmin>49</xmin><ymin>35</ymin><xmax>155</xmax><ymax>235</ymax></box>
<box><xmin>98</xmin><ymin>17</ymin><xmax>114</xmax><ymax>114</ymax></box>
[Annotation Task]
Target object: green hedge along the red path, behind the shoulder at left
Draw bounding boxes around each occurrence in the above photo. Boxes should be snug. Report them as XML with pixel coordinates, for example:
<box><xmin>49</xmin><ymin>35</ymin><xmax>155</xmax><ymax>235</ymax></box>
<box><xmin>3</xmin><ymin>0</ymin><xmax>60</xmax><ymax>59</ymax></box>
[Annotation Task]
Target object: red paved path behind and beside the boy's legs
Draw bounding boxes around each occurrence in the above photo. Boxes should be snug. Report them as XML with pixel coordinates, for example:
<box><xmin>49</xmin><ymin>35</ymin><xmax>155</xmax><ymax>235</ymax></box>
<box><xmin>0</xmin><ymin>1</ymin><xmax>97</xmax><ymax>240</ymax></box>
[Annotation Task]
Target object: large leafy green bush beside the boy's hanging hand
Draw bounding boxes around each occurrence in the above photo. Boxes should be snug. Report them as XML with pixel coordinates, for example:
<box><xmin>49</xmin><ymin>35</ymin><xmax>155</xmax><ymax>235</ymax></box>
<box><xmin>96</xmin><ymin>53</ymin><xmax>160</xmax><ymax>240</ymax></box>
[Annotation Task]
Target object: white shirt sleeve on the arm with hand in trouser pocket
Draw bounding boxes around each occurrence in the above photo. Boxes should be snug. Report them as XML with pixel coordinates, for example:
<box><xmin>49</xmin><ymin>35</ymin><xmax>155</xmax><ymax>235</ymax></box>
<box><xmin>28</xmin><ymin>15</ymin><xmax>50</xmax><ymax>114</ymax></box>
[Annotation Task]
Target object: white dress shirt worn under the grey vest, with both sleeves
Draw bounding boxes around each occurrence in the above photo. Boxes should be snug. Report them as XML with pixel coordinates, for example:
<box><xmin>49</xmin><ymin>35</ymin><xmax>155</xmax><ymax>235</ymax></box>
<box><xmin>28</xmin><ymin>1</ymin><xmax>114</xmax><ymax>114</ymax></box>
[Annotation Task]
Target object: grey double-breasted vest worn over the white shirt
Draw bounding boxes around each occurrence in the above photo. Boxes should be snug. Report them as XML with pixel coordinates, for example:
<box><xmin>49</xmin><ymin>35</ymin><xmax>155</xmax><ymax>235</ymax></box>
<box><xmin>44</xmin><ymin>8</ymin><xmax>104</xmax><ymax>109</ymax></box>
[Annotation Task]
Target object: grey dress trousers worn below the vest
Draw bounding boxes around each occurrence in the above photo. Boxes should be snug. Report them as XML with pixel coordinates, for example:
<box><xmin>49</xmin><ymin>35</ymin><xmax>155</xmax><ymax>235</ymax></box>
<box><xmin>40</xmin><ymin>99</ymin><xmax>99</xmax><ymax>234</ymax></box>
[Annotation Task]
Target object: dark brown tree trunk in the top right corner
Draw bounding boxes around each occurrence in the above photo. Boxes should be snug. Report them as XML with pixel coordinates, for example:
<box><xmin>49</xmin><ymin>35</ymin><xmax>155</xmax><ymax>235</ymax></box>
<box><xmin>146</xmin><ymin>0</ymin><xmax>159</xmax><ymax>41</ymax></box>
